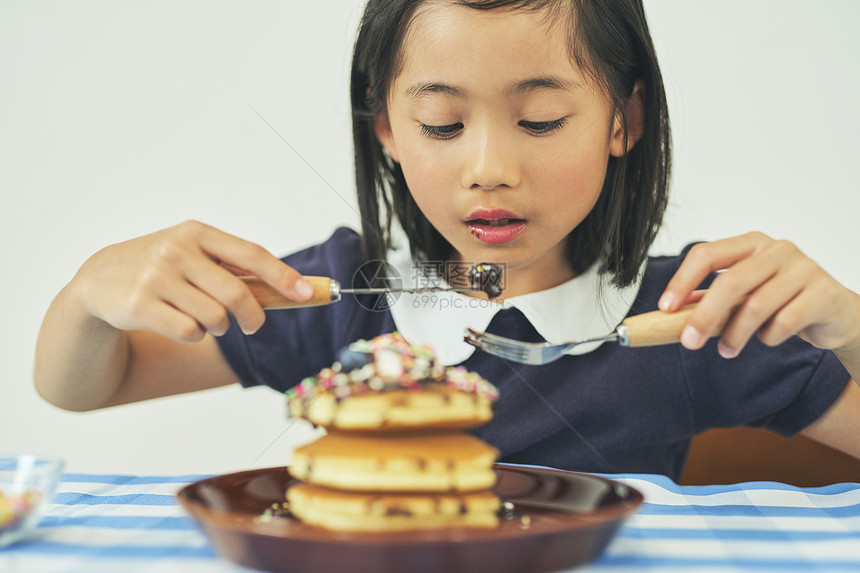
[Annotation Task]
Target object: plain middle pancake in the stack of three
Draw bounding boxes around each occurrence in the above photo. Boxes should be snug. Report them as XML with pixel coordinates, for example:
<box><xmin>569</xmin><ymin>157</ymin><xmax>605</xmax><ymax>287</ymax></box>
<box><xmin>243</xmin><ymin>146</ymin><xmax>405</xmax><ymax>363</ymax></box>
<box><xmin>290</xmin><ymin>432</ymin><xmax>498</xmax><ymax>492</ymax></box>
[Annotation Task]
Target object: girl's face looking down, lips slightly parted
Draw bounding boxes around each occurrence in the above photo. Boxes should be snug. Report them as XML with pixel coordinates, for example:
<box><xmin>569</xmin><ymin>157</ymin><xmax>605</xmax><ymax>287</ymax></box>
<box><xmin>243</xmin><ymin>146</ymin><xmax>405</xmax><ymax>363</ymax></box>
<box><xmin>377</xmin><ymin>2</ymin><xmax>632</xmax><ymax>296</ymax></box>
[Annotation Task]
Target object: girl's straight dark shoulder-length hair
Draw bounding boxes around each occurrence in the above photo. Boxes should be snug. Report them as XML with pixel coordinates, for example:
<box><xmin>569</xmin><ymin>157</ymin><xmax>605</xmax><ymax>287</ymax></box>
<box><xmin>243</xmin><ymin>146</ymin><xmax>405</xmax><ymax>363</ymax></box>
<box><xmin>350</xmin><ymin>0</ymin><xmax>671</xmax><ymax>286</ymax></box>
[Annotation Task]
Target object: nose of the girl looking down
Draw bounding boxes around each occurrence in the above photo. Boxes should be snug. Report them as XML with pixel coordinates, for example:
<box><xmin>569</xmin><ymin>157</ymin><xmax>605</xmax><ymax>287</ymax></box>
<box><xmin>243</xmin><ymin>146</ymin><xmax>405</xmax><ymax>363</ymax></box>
<box><xmin>462</xmin><ymin>132</ymin><xmax>520</xmax><ymax>189</ymax></box>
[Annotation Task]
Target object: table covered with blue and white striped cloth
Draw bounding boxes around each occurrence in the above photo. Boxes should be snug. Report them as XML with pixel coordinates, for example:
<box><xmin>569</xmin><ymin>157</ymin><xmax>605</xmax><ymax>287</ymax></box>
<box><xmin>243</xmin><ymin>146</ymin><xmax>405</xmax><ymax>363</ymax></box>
<box><xmin>0</xmin><ymin>474</ymin><xmax>860</xmax><ymax>573</ymax></box>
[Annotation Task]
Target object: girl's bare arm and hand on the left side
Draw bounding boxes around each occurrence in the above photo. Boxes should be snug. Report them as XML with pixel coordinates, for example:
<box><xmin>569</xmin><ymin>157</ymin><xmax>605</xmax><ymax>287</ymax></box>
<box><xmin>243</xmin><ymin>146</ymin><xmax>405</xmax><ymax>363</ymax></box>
<box><xmin>34</xmin><ymin>221</ymin><xmax>311</xmax><ymax>410</ymax></box>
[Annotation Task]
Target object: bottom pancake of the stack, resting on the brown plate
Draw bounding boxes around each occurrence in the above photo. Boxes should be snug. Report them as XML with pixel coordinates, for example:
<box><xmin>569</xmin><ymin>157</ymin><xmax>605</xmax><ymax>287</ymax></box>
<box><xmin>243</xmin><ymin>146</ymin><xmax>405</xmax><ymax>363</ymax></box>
<box><xmin>287</xmin><ymin>483</ymin><xmax>499</xmax><ymax>532</ymax></box>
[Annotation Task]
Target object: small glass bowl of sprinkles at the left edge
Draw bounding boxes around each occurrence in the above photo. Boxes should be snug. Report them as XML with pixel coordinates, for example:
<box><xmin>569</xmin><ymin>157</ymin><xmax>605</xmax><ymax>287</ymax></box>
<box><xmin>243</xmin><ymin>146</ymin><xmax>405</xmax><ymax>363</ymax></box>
<box><xmin>0</xmin><ymin>454</ymin><xmax>64</xmax><ymax>547</ymax></box>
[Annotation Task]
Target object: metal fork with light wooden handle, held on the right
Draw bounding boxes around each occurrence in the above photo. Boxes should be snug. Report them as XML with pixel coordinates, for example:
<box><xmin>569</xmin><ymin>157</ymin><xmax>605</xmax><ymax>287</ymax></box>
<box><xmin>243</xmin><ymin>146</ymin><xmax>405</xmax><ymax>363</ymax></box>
<box><xmin>463</xmin><ymin>304</ymin><xmax>729</xmax><ymax>364</ymax></box>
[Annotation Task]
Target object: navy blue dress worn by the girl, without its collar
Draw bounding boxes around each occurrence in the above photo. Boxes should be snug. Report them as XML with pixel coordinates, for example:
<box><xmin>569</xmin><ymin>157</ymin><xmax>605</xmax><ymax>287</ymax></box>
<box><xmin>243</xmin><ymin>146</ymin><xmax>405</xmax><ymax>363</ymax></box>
<box><xmin>218</xmin><ymin>228</ymin><xmax>850</xmax><ymax>481</ymax></box>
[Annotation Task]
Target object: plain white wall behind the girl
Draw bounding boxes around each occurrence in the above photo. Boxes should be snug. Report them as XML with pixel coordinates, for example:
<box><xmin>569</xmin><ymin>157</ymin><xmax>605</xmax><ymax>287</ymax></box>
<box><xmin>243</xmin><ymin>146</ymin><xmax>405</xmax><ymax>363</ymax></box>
<box><xmin>0</xmin><ymin>0</ymin><xmax>860</xmax><ymax>474</ymax></box>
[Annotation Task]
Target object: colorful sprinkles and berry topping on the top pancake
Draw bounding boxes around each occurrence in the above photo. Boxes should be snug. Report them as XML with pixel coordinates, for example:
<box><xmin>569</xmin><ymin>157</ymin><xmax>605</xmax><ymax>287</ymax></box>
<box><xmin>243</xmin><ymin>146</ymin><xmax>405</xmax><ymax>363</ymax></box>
<box><xmin>285</xmin><ymin>332</ymin><xmax>499</xmax><ymax>402</ymax></box>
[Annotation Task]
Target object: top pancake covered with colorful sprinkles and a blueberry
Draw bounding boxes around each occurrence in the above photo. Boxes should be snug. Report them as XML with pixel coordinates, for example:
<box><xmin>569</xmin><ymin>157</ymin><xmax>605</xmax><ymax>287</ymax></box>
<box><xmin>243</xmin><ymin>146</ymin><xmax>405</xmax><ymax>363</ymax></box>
<box><xmin>286</xmin><ymin>332</ymin><xmax>498</xmax><ymax>431</ymax></box>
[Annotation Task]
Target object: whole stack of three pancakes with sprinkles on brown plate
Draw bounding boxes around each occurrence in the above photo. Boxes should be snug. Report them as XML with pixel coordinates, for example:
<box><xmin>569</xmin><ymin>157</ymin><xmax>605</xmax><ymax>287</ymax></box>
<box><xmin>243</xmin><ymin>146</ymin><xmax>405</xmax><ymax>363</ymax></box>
<box><xmin>287</xmin><ymin>332</ymin><xmax>499</xmax><ymax>531</ymax></box>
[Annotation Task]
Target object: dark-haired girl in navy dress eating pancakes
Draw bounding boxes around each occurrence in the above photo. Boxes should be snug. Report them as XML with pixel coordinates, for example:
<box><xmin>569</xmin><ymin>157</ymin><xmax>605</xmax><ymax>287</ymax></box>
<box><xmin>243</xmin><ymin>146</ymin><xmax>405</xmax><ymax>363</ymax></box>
<box><xmin>35</xmin><ymin>0</ymin><xmax>860</xmax><ymax>479</ymax></box>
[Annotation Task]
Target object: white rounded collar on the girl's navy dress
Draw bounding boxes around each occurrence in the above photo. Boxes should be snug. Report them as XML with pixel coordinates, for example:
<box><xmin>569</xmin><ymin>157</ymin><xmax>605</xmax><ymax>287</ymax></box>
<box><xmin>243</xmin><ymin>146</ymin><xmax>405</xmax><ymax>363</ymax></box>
<box><xmin>388</xmin><ymin>238</ymin><xmax>644</xmax><ymax>365</ymax></box>
